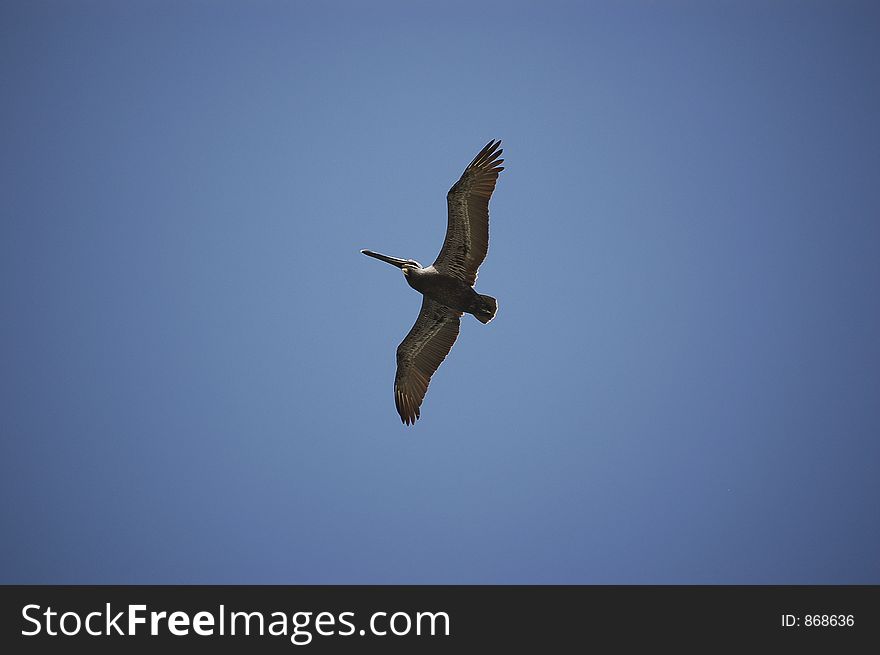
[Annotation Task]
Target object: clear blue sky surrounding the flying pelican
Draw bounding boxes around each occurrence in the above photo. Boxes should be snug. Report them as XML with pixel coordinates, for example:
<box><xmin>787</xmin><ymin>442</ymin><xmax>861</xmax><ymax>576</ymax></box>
<box><xmin>0</xmin><ymin>0</ymin><xmax>880</xmax><ymax>584</ymax></box>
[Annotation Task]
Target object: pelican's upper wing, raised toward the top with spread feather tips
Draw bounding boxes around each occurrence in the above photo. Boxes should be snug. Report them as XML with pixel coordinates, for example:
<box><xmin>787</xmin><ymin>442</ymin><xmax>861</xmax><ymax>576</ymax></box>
<box><xmin>434</xmin><ymin>141</ymin><xmax>504</xmax><ymax>286</ymax></box>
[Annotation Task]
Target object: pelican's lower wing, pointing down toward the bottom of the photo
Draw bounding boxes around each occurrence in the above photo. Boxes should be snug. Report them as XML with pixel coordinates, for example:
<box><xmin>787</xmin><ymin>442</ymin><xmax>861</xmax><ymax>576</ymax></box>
<box><xmin>394</xmin><ymin>297</ymin><xmax>461</xmax><ymax>425</ymax></box>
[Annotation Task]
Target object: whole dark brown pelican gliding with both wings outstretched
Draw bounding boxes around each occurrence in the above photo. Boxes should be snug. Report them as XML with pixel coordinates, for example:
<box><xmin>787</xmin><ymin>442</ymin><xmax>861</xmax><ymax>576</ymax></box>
<box><xmin>361</xmin><ymin>141</ymin><xmax>504</xmax><ymax>425</ymax></box>
